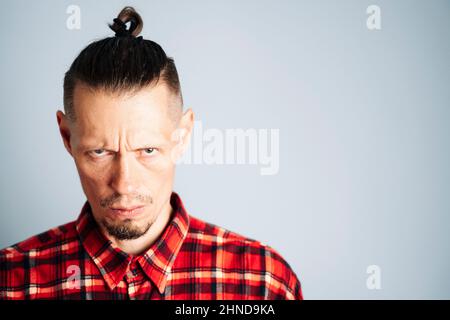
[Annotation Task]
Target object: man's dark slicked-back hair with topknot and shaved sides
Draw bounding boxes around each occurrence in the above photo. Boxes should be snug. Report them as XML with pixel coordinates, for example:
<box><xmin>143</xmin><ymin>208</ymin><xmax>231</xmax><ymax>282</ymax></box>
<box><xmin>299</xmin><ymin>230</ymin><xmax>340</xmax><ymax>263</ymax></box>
<box><xmin>64</xmin><ymin>7</ymin><xmax>183</xmax><ymax>120</ymax></box>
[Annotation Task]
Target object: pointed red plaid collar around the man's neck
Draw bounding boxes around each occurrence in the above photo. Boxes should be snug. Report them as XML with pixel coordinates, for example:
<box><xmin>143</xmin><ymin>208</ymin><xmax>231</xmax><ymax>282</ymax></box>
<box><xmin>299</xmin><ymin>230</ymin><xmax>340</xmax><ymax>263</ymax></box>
<box><xmin>76</xmin><ymin>192</ymin><xmax>189</xmax><ymax>294</ymax></box>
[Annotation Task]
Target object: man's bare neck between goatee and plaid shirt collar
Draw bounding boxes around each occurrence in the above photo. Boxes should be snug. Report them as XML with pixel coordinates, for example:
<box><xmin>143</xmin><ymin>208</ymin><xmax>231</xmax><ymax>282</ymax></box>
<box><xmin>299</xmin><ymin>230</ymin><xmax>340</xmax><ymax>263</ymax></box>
<box><xmin>103</xmin><ymin>201</ymin><xmax>172</xmax><ymax>255</ymax></box>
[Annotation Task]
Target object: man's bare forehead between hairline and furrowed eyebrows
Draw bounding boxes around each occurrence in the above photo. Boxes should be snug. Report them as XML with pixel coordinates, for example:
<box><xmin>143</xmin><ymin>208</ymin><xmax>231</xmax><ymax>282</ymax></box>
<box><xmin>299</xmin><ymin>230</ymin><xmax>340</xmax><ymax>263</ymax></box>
<box><xmin>73</xmin><ymin>84</ymin><xmax>173</xmax><ymax>140</ymax></box>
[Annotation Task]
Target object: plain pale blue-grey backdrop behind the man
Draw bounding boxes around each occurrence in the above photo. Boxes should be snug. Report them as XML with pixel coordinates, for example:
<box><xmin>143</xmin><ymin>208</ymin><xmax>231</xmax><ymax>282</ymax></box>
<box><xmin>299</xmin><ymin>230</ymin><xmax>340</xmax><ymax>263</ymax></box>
<box><xmin>0</xmin><ymin>0</ymin><xmax>450</xmax><ymax>299</ymax></box>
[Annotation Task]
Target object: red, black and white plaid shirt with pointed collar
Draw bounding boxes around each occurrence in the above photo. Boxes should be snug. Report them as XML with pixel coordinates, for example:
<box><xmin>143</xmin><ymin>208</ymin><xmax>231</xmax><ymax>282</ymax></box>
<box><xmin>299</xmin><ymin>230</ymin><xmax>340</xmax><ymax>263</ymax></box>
<box><xmin>0</xmin><ymin>192</ymin><xmax>303</xmax><ymax>300</ymax></box>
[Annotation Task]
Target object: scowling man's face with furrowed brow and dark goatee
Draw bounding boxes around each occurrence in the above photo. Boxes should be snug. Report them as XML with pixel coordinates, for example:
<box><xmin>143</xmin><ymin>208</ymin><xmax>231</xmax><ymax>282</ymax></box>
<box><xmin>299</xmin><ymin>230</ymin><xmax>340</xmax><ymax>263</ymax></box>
<box><xmin>58</xmin><ymin>84</ymin><xmax>193</xmax><ymax>240</ymax></box>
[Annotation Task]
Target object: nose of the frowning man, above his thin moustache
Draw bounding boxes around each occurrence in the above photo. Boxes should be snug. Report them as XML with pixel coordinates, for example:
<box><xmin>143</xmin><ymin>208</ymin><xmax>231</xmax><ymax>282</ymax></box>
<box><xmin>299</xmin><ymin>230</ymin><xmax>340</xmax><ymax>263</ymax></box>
<box><xmin>111</xmin><ymin>153</ymin><xmax>137</xmax><ymax>195</ymax></box>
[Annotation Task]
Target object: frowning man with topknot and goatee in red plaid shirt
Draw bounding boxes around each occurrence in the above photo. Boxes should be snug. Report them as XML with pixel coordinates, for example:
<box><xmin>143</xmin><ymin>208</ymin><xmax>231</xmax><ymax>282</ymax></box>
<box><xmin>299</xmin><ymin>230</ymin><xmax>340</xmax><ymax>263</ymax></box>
<box><xmin>0</xmin><ymin>7</ymin><xmax>303</xmax><ymax>299</ymax></box>
